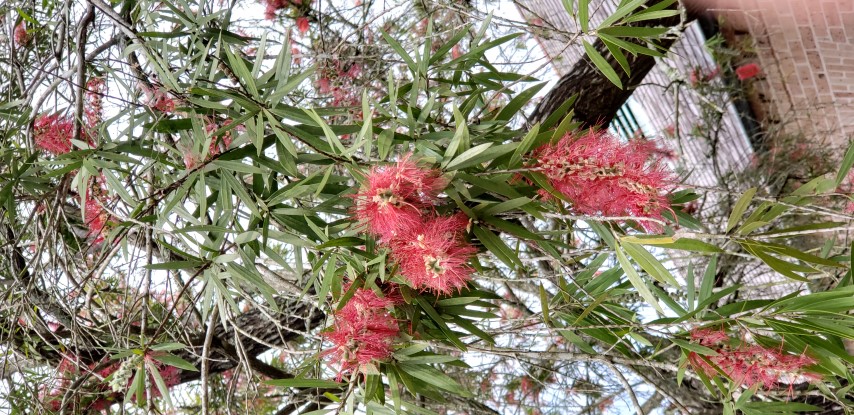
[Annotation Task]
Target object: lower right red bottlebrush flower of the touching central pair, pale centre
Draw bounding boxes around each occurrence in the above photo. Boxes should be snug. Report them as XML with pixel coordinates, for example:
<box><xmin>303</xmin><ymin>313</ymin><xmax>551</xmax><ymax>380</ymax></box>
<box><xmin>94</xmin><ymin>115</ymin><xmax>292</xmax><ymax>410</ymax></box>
<box><xmin>391</xmin><ymin>214</ymin><xmax>477</xmax><ymax>294</ymax></box>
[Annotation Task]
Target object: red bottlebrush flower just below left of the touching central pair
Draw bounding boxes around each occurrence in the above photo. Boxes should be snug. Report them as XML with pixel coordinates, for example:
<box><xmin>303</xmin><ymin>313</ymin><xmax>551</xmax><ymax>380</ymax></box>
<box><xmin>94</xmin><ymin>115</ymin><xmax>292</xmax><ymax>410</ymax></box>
<box><xmin>321</xmin><ymin>287</ymin><xmax>400</xmax><ymax>381</ymax></box>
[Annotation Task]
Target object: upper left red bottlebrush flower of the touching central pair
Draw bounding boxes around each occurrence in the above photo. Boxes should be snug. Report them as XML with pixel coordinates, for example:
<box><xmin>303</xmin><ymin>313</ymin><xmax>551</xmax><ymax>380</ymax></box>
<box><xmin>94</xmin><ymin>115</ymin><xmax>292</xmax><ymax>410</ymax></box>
<box><xmin>353</xmin><ymin>155</ymin><xmax>446</xmax><ymax>240</ymax></box>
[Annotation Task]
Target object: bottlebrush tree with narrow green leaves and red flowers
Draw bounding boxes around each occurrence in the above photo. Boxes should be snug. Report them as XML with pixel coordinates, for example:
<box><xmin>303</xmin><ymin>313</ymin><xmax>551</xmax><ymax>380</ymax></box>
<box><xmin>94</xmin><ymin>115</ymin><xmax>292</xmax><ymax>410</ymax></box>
<box><xmin>0</xmin><ymin>0</ymin><xmax>854</xmax><ymax>414</ymax></box>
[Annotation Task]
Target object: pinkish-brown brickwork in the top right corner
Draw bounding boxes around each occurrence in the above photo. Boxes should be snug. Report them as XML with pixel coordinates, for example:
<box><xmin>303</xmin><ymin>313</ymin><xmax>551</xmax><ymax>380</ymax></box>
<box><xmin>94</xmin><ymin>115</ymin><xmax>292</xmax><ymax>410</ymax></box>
<box><xmin>689</xmin><ymin>0</ymin><xmax>854</xmax><ymax>147</ymax></box>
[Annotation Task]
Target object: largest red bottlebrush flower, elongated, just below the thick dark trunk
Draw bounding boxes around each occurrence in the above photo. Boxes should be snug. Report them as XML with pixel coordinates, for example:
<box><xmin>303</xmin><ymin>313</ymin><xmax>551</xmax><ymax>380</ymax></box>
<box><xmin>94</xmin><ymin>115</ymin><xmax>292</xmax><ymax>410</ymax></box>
<box><xmin>534</xmin><ymin>130</ymin><xmax>672</xmax><ymax>232</ymax></box>
